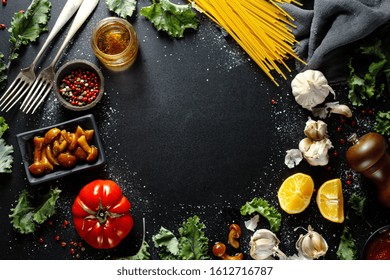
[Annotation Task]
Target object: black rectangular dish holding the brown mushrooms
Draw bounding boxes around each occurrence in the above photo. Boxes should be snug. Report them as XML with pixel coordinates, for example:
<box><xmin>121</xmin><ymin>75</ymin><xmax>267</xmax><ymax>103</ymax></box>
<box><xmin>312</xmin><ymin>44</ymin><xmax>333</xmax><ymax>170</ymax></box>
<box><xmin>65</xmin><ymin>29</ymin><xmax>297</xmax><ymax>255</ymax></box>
<box><xmin>16</xmin><ymin>114</ymin><xmax>106</xmax><ymax>185</ymax></box>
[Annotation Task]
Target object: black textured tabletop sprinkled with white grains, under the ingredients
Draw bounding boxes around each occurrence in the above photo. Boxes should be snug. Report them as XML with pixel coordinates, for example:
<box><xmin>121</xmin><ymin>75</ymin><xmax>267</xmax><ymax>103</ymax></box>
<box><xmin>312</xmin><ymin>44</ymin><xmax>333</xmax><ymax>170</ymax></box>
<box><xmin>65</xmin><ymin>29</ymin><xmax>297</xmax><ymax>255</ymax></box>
<box><xmin>0</xmin><ymin>0</ymin><xmax>390</xmax><ymax>259</ymax></box>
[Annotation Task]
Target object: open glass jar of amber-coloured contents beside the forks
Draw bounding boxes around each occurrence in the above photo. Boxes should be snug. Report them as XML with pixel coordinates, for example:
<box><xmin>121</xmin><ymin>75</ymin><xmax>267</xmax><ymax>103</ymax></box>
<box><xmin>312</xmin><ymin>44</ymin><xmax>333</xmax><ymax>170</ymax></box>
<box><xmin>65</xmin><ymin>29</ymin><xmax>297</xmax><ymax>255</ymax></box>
<box><xmin>91</xmin><ymin>17</ymin><xmax>138</xmax><ymax>71</ymax></box>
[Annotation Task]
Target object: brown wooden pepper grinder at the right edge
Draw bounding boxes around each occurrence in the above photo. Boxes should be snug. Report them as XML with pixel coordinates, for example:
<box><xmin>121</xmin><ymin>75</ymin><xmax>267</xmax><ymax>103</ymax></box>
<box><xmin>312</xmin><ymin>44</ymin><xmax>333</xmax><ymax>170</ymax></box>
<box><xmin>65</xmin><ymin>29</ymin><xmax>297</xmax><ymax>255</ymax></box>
<box><xmin>346</xmin><ymin>132</ymin><xmax>390</xmax><ymax>207</ymax></box>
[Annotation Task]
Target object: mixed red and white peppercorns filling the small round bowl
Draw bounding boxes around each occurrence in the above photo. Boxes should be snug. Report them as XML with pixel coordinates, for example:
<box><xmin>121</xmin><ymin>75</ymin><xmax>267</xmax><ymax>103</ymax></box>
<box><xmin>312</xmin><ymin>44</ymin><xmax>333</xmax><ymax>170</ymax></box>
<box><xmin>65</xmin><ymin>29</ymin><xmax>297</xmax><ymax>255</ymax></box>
<box><xmin>60</xmin><ymin>68</ymin><xmax>99</xmax><ymax>106</ymax></box>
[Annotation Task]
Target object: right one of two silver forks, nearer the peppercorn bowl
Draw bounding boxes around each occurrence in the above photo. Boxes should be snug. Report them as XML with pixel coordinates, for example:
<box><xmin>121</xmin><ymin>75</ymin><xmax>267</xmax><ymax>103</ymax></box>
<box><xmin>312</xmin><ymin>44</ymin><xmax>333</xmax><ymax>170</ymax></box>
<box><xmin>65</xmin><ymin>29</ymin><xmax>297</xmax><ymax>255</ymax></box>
<box><xmin>20</xmin><ymin>0</ymin><xmax>99</xmax><ymax>114</ymax></box>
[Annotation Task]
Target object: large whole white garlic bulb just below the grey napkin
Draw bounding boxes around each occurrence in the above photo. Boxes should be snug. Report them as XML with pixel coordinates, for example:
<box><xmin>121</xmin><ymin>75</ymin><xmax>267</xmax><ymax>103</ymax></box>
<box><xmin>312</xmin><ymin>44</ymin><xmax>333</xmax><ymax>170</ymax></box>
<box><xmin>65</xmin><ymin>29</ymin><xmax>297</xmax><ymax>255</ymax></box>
<box><xmin>291</xmin><ymin>70</ymin><xmax>335</xmax><ymax>111</ymax></box>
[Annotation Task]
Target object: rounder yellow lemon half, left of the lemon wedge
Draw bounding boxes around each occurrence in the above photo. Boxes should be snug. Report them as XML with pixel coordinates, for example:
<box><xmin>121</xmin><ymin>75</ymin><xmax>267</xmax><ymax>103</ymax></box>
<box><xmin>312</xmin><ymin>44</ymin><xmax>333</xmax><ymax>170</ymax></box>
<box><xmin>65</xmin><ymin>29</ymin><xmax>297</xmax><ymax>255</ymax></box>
<box><xmin>278</xmin><ymin>173</ymin><xmax>314</xmax><ymax>214</ymax></box>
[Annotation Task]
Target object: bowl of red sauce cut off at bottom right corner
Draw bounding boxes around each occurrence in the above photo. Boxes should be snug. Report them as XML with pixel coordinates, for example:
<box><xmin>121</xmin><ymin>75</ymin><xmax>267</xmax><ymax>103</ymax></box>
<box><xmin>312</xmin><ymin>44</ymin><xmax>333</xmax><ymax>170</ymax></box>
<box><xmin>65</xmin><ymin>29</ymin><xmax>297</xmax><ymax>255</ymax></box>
<box><xmin>362</xmin><ymin>225</ymin><xmax>390</xmax><ymax>260</ymax></box>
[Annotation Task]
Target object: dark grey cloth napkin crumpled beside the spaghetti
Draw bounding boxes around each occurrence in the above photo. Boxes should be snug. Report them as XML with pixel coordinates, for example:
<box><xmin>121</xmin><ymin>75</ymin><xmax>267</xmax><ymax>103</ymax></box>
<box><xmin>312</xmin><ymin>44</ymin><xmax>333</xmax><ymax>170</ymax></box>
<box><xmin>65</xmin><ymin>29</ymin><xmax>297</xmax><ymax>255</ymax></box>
<box><xmin>282</xmin><ymin>0</ymin><xmax>390</xmax><ymax>84</ymax></box>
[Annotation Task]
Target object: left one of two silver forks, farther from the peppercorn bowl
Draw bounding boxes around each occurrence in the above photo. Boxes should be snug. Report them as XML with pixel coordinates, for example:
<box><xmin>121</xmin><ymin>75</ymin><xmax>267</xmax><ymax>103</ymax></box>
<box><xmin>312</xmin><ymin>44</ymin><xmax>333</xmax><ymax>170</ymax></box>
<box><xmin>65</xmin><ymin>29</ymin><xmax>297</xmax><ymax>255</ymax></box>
<box><xmin>0</xmin><ymin>0</ymin><xmax>83</xmax><ymax>112</ymax></box>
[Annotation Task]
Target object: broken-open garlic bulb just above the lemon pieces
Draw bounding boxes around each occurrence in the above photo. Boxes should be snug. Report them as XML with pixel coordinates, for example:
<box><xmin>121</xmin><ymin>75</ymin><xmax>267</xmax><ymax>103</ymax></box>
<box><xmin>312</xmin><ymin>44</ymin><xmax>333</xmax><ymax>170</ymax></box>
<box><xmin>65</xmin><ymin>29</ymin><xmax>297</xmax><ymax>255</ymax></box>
<box><xmin>299</xmin><ymin>138</ymin><xmax>332</xmax><ymax>166</ymax></box>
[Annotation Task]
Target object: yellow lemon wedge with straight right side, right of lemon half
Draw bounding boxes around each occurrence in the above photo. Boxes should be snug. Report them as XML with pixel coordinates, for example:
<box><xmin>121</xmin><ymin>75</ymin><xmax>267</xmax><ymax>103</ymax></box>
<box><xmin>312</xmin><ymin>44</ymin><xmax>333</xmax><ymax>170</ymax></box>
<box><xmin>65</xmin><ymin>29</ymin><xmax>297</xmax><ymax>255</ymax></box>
<box><xmin>316</xmin><ymin>178</ymin><xmax>344</xmax><ymax>223</ymax></box>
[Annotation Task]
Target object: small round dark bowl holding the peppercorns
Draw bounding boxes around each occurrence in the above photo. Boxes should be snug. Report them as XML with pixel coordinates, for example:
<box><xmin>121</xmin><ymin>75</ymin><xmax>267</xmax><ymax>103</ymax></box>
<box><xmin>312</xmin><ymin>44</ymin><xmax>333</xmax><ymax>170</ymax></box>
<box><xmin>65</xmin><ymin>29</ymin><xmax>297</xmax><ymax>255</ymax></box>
<box><xmin>54</xmin><ymin>59</ymin><xmax>104</xmax><ymax>111</ymax></box>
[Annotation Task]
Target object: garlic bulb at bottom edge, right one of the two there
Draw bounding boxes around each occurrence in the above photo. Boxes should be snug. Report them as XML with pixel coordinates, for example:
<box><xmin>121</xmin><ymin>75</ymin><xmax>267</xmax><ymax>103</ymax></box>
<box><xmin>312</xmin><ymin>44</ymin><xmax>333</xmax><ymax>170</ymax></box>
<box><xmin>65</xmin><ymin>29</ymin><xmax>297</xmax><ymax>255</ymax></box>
<box><xmin>295</xmin><ymin>226</ymin><xmax>328</xmax><ymax>259</ymax></box>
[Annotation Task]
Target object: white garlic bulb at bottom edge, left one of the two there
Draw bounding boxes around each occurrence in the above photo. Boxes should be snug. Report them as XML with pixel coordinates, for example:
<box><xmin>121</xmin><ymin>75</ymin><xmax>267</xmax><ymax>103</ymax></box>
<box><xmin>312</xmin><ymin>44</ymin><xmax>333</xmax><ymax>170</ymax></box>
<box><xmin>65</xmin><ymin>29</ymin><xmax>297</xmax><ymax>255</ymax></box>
<box><xmin>249</xmin><ymin>229</ymin><xmax>286</xmax><ymax>260</ymax></box>
